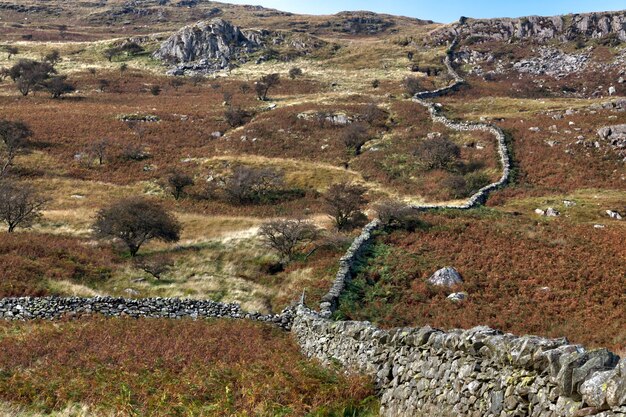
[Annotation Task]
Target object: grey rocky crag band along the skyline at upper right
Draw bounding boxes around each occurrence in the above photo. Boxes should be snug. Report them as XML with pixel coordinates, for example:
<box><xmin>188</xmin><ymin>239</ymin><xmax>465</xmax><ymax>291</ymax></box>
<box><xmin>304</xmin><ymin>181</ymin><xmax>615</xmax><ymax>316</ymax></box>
<box><xmin>435</xmin><ymin>10</ymin><xmax>626</xmax><ymax>42</ymax></box>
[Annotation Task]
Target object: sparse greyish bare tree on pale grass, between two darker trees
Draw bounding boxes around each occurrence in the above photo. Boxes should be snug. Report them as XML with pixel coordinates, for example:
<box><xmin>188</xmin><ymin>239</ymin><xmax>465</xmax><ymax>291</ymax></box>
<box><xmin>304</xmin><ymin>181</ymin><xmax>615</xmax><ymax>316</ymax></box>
<box><xmin>259</xmin><ymin>219</ymin><xmax>319</xmax><ymax>264</ymax></box>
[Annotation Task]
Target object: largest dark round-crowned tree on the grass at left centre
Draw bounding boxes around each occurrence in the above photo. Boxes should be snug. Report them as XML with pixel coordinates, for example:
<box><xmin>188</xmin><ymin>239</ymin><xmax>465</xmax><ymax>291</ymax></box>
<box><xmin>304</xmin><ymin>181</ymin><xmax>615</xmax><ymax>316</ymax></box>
<box><xmin>92</xmin><ymin>197</ymin><xmax>182</xmax><ymax>257</ymax></box>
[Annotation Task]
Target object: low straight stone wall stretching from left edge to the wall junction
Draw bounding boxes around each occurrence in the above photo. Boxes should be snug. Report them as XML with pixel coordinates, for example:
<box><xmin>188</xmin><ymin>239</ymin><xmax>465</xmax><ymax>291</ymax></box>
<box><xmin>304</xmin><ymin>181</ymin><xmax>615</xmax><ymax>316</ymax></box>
<box><xmin>0</xmin><ymin>297</ymin><xmax>292</xmax><ymax>330</ymax></box>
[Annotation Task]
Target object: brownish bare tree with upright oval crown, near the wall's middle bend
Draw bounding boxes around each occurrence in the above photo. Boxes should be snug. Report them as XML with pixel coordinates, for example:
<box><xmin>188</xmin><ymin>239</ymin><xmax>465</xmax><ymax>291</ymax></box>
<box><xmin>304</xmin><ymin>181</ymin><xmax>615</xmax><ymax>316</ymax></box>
<box><xmin>324</xmin><ymin>182</ymin><xmax>367</xmax><ymax>230</ymax></box>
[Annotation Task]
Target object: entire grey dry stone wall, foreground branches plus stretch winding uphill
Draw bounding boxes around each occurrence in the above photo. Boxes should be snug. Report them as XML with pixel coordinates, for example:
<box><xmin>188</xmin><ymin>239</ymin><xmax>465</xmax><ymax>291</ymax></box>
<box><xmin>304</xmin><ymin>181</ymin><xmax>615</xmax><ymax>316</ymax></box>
<box><xmin>0</xmin><ymin>35</ymin><xmax>626</xmax><ymax>417</ymax></box>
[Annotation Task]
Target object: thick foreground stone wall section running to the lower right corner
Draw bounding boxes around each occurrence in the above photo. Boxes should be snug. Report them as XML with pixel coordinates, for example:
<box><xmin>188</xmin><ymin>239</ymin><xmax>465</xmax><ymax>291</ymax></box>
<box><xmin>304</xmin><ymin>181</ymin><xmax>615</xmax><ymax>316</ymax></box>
<box><xmin>292</xmin><ymin>306</ymin><xmax>626</xmax><ymax>417</ymax></box>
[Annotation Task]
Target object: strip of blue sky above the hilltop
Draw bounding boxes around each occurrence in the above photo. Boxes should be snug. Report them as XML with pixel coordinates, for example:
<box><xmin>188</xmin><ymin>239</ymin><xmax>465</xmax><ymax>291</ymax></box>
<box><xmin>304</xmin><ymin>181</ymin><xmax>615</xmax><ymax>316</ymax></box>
<box><xmin>224</xmin><ymin>0</ymin><xmax>626</xmax><ymax>23</ymax></box>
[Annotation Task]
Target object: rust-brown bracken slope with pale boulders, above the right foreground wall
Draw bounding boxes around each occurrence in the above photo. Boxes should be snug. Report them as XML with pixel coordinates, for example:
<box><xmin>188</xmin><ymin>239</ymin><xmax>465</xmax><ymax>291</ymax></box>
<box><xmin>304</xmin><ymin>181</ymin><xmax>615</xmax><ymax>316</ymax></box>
<box><xmin>341</xmin><ymin>209</ymin><xmax>626</xmax><ymax>351</ymax></box>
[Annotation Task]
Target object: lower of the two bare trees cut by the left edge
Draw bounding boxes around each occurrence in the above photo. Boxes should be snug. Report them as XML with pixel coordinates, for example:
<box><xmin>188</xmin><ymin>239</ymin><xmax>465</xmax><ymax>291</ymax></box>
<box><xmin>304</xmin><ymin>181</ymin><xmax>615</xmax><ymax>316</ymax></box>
<box><xmin>0</xmin><ymin>181</ymin><xmax>48</xmax><ymax>233</ymax></box>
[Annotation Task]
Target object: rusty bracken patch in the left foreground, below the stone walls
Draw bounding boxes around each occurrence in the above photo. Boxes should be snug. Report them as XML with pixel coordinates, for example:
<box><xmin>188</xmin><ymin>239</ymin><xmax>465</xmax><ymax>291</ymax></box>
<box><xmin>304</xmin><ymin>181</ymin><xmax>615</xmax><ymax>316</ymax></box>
<box><xmin>0</xmin><ymin>318</ymin><xmax>378</xmax><ymax>417</ymax></box>
